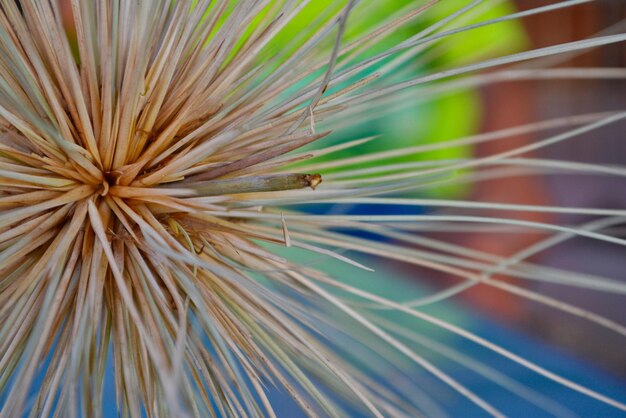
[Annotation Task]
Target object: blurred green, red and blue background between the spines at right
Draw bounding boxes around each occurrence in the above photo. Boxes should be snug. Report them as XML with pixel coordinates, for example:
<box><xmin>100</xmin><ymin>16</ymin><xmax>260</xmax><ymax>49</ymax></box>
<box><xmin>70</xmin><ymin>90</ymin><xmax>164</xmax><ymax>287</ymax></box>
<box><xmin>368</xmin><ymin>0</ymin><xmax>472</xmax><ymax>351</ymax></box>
<box><xmin>286</xmin><ymin>0</ymin><xmax>626</xmax><ymax>417</ymax></box>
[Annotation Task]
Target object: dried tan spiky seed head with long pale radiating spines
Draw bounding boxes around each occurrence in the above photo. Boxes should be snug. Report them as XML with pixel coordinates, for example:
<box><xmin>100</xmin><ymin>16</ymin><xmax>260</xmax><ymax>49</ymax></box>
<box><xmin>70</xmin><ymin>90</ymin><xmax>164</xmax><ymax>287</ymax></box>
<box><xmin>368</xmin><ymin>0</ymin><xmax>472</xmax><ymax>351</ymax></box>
<box><xmin>0</xmin><ymin>0</ymin><xmax>626</xmax><ymax>417</ymax></box>
